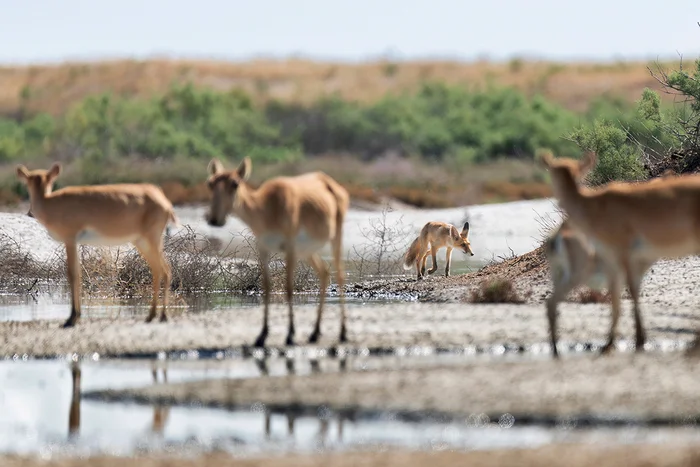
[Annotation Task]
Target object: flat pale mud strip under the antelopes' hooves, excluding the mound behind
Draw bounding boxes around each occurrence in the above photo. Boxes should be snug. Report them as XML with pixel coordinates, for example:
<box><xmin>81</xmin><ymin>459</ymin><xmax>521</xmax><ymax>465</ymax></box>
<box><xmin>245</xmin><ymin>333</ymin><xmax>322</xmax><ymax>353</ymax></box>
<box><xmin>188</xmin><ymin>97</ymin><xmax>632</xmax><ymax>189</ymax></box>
<box><xmin>0</xmin><ymin>302</ymin><xmax>700</xmax><ymax>358</ymax></box>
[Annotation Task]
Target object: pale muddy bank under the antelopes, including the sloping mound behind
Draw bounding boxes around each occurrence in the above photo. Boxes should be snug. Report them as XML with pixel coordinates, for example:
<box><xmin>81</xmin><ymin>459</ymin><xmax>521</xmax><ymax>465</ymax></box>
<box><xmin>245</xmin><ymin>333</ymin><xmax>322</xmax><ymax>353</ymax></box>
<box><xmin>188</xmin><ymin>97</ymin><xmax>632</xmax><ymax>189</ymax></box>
<box><xmin>0</xmin><ymin>247</ymin><xmax>700</xmax><ymax>357</ymax></box>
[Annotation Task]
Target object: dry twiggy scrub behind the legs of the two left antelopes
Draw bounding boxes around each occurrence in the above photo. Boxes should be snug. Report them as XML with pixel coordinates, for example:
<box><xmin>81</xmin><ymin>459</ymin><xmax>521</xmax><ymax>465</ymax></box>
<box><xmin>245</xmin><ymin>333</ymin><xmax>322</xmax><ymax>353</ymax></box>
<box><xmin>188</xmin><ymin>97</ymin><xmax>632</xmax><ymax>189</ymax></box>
<box><xmin>0</xmin><ymin>227</ymin><xmax>318</xmax><ymax>298</ymax></box>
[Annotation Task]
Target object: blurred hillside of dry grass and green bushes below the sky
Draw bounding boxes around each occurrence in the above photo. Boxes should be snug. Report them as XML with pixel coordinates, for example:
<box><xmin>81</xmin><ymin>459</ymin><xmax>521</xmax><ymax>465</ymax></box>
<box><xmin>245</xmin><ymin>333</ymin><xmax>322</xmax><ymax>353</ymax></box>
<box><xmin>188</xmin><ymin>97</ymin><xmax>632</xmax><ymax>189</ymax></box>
<box><xmin>0</xmin><ymin>60</ymin><xmax>684</xmax><ymax>207</ymax></box>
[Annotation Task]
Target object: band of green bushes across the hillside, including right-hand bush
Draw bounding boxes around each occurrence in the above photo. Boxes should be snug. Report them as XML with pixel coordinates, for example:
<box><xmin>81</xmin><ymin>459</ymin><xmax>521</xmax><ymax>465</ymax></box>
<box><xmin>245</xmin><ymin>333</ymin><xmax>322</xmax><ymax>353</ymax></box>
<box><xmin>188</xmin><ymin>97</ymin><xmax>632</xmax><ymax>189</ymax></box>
<box><xmin>0</xmin><ymin>77</ymin><xmax>690</xmax><ymax>183</ymax></box>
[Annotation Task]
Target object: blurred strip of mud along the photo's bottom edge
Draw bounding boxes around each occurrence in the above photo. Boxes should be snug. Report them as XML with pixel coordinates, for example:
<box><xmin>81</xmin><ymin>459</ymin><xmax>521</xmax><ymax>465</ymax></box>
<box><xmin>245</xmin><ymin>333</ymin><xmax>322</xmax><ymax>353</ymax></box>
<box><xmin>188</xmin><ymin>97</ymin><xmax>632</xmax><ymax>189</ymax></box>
<box><xmin>0</xmin><ymin>443</ymin><xmax>700</xmax><ymax>467</ymax></box>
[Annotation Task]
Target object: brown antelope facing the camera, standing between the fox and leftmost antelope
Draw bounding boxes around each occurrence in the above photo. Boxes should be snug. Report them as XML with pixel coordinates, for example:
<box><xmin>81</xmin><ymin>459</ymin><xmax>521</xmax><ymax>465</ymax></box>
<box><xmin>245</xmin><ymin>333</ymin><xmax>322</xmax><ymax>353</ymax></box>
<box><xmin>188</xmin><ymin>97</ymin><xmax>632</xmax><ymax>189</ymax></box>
<box><xmin>207</xmin><ymin>157</ymin><xmax>350</xmax><ymax>347</ymax></box>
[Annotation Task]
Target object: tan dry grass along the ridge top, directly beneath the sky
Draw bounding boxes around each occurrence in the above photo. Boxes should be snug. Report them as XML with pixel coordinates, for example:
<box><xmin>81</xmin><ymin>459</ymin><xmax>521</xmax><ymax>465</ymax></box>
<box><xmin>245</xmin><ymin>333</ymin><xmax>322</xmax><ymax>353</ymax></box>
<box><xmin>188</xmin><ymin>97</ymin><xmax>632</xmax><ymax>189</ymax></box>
<box><xmin>0</xmin><ymin>60</ymin><xmax>677</xmax><ymax>115</ymax></box>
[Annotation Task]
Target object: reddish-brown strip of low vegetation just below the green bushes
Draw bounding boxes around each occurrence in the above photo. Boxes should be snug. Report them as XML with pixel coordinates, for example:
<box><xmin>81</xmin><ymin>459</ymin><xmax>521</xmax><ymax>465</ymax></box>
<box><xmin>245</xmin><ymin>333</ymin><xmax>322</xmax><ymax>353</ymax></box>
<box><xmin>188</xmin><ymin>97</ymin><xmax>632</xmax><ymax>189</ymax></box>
<box><xmin>0</xmin><ymin>154</ymin><xmax>552</xmax><ymax>208</ymax></box>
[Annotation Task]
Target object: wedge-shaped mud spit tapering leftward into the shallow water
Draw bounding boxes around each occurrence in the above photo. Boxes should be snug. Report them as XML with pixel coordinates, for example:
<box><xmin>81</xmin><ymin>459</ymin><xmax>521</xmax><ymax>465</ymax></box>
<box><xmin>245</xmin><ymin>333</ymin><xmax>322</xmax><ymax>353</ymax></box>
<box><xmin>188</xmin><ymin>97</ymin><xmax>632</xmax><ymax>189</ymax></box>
<box><xmin>83</xmin><ymin>352</ymin><xmax>700</xmax><ymax>427</ymax></box>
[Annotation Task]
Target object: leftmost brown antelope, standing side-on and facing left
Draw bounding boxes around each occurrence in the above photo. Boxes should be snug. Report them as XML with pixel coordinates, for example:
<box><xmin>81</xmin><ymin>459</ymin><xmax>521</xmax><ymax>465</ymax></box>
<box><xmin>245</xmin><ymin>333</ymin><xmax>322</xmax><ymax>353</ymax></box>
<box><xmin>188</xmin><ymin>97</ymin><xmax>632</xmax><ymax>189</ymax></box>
<box><xmin>17</xmin><ymin>163</ymin><xmax>178</xmax><ymax>327</ymax></box>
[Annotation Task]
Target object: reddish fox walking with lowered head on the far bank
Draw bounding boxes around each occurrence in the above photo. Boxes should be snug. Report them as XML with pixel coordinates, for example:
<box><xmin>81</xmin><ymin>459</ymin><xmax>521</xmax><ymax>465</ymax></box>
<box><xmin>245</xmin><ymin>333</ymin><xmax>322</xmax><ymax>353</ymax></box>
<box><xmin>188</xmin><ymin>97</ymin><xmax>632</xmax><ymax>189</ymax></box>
<box><xmin>403</xmin><ymin>221</ymin><xmax>474</xmax><ymax>280</ymax></box>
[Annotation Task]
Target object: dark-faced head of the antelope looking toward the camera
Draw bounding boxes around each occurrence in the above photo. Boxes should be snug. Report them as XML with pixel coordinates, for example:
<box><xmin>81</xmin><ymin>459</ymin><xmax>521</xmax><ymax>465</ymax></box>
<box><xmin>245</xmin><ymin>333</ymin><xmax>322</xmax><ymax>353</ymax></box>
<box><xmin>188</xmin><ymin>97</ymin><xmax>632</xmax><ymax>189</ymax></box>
<box><xmin>205</xmin><ymin>157</ymin><xmax>251</xmax><ymax>227</ymax></box>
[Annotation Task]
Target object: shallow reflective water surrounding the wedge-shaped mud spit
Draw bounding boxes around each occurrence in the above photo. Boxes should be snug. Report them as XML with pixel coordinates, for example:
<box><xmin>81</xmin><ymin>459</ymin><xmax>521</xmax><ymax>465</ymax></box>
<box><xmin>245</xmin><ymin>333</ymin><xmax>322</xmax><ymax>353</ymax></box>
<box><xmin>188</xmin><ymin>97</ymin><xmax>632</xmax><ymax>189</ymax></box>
<box><xmin>5</xmin><ymin>357</ymin><xmax>700</xmax><ymax>456</ymax></box>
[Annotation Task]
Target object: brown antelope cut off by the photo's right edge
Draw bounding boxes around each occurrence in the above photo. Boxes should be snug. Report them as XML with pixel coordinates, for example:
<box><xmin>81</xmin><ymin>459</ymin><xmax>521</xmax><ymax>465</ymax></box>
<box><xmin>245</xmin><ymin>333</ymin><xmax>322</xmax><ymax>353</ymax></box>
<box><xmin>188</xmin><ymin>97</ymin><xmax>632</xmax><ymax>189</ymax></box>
<box><xmin>541</xmin><ymin>152</ymin><xmax>700</xmax><ymax>351</ymax></box>
